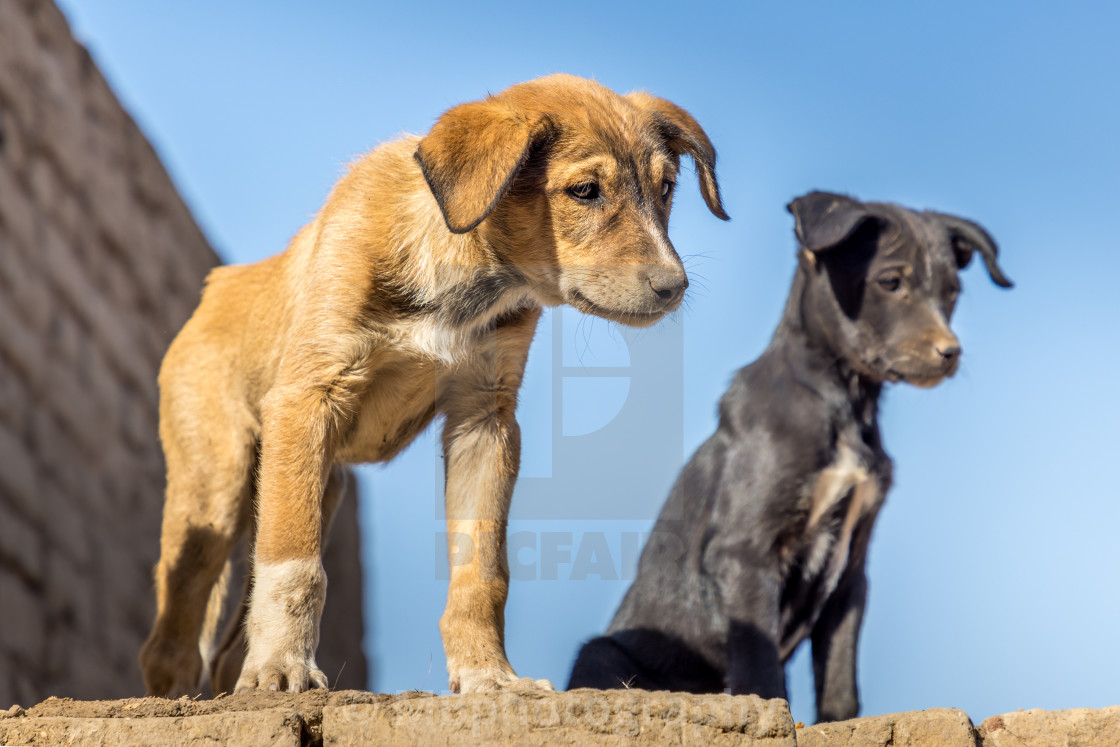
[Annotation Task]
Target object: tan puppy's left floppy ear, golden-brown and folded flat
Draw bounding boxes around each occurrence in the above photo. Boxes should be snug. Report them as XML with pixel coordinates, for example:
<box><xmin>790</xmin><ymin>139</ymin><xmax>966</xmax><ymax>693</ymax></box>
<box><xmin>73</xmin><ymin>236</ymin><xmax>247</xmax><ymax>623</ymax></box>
<box><xmin>414</xmin><ymin>97</ymin><xmax>553</xmax><ymax>233</ymax></box>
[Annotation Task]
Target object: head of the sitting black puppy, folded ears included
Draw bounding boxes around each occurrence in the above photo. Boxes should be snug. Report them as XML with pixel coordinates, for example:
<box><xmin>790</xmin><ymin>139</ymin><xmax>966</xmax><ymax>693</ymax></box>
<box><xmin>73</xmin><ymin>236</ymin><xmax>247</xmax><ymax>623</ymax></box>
<box><xmin>787</xmin><ymin>192</ymin><xmax>1011</xmax><ymax>386</ymax></box>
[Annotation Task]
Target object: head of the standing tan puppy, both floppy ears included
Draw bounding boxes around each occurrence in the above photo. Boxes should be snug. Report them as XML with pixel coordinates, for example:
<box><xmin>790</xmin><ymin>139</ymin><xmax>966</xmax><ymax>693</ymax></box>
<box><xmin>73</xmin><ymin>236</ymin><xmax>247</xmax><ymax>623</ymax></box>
<box><xmin>416</xmin><ymin>75</ymin><xmax>727</xmax><ymax>326</ymax></box>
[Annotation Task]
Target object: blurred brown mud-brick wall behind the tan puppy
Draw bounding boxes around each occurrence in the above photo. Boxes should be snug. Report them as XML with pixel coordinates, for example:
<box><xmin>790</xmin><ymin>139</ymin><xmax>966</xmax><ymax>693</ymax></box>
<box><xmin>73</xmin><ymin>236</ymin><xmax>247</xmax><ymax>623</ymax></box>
<box><xmin>0</xmin><ymin>0</ymin><xmax>366</xmax><ymax>704</ymax></box>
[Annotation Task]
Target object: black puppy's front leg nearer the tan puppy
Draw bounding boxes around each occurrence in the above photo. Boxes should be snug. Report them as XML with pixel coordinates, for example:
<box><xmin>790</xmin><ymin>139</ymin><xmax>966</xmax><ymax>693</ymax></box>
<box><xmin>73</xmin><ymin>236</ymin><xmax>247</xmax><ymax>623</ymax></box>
<box><xmin>717</xmin><ymin>557</ymin><xmax>786</xmax><ymax>698</ymax></box>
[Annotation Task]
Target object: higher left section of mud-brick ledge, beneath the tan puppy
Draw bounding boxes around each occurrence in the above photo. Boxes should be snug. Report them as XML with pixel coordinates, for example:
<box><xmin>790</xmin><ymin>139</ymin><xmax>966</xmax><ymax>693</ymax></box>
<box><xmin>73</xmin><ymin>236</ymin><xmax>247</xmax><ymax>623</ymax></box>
<box><xmin>0</xmin><ymin>690</ymin><xmax>796</xmax><ymax>747</ymax></box>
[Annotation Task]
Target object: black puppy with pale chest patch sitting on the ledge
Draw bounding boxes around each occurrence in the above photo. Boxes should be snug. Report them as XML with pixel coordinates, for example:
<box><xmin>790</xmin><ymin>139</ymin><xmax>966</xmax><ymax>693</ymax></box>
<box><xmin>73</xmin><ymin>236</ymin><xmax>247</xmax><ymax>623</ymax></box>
<box><xmin>568</xmin><ymin>192</ymin><xmax>1011</xmax><ymax>721</ymax></box>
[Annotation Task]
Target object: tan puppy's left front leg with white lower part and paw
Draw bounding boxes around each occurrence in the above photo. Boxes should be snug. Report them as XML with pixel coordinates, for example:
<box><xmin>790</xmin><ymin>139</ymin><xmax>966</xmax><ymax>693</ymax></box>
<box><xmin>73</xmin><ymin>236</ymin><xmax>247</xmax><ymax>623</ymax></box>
<box><xmin>236</xmin><ymin>387</ymin><xmax>335</xmax><ymax>692</ymax></box>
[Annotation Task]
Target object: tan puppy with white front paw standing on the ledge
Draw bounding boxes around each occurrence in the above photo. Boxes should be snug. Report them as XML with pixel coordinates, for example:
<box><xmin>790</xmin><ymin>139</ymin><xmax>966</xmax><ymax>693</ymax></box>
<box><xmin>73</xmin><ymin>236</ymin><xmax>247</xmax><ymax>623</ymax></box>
<box><xmin>140</xmin><ymin>75</ymin><xmax>727</xmax><ymax>697</ymax></box>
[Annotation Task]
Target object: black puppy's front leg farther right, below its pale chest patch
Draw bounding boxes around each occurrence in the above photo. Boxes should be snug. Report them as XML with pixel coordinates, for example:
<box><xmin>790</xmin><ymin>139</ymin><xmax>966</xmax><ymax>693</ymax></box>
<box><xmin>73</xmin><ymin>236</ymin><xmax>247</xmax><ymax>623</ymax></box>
<box><xmin>812</xmin><ymin>566</ymin><xmax>867</xmax><ymax>722</ymax></box>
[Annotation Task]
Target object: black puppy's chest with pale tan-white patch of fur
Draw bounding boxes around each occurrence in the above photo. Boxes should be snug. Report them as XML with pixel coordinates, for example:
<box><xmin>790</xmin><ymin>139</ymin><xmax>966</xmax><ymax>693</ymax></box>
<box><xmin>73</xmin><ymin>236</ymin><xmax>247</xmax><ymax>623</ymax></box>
<box><xmin>780</xmin><ymin>433</ymin><xmax>890</xmax><ymax>660</ymax></box>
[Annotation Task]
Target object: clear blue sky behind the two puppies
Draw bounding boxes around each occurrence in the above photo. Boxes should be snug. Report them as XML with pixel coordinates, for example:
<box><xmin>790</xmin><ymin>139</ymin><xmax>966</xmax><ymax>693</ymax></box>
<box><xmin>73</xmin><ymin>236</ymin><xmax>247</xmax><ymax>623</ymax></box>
<box><xmin>62</xmin><ymin>0</ymin><xmax>1120</xmax><ymax>721</ymax></box>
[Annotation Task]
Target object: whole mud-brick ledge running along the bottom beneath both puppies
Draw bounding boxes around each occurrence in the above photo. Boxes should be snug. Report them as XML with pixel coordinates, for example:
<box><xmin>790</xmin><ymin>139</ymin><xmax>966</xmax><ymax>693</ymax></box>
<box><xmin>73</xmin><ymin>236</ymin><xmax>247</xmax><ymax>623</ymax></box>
<box><xmin>0</xmin><ymin>690</ymin><xmax>1120</xmax><ymax>747</ymax></box>
